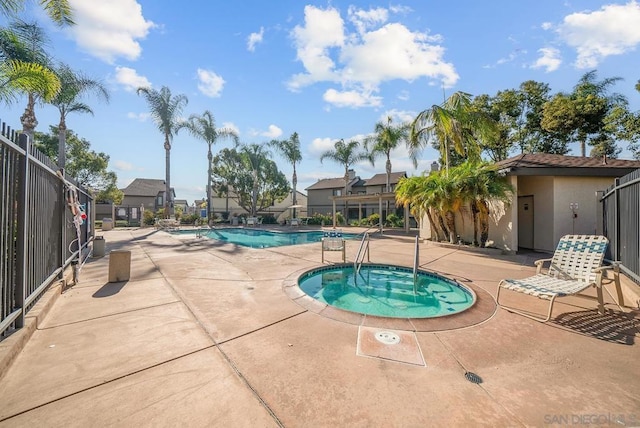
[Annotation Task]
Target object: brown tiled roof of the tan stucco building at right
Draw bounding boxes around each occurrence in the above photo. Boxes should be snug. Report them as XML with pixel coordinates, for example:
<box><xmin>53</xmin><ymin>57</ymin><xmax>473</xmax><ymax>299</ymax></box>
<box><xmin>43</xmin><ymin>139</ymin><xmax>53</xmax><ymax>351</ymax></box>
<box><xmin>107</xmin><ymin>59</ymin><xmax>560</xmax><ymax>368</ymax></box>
<box><xmin>496</xmin><ymin>153</ymin><xmax>640</xmax><ymax>177</ymax></box>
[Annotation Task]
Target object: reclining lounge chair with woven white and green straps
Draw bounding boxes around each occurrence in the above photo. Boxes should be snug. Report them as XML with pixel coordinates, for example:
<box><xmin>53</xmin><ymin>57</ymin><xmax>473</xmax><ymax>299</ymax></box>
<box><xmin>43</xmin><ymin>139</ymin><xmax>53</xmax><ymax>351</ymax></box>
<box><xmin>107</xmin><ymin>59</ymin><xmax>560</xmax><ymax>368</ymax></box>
<box><xmin>496</xmin><ymin>235</ymin><xmax>609</xmax><ymax>322</ymax></box>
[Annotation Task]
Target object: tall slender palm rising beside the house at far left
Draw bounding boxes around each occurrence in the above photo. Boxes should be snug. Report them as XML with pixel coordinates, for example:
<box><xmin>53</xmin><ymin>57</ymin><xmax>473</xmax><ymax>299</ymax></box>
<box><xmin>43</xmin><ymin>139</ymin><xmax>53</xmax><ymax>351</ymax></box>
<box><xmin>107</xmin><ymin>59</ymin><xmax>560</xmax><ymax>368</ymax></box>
<box><xmin>137</xmin><ymin>86</ymin><xmax>189</xmax><ymax>218</ymax></box>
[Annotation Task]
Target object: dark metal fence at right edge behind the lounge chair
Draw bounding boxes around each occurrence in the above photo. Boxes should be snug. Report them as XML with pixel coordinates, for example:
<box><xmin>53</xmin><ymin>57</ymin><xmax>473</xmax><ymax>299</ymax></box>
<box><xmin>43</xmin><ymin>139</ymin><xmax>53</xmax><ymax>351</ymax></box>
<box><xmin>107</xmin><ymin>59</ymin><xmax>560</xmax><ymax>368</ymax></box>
<box><xmin>601</xmin><ymin>169</ymin><xmax>640</xmax><ymax>284</ymax></box>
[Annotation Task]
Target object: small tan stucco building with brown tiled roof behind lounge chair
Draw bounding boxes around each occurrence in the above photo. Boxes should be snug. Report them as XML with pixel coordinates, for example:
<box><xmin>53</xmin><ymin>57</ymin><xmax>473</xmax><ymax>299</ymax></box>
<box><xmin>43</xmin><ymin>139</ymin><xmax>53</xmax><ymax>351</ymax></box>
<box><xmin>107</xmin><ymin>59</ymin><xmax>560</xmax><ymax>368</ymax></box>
<box><xmin>420</xmin><ymin>153</ymin><xmax>640</xmax><ymax>253</ymax></box>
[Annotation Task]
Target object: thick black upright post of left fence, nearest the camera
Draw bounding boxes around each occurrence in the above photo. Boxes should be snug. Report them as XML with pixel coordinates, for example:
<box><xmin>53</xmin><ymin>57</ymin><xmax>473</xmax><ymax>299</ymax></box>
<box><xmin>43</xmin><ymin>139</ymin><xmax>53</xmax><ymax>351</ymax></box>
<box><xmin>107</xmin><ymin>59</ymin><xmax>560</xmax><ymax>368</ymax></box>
<box><xmin>15</xmin><ymin>134</ymin><xmax>31</xmax><ymax>328</ymax></box>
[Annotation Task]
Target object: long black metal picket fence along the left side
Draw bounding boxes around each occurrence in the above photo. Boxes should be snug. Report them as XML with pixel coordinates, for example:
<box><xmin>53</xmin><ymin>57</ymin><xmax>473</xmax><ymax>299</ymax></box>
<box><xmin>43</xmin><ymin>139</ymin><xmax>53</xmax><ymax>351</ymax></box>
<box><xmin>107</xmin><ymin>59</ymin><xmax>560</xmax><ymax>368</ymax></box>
<box><xmin>0</xmin><ymin>119</ymin><xmax>94</xmax><ymax>339</ymax></box>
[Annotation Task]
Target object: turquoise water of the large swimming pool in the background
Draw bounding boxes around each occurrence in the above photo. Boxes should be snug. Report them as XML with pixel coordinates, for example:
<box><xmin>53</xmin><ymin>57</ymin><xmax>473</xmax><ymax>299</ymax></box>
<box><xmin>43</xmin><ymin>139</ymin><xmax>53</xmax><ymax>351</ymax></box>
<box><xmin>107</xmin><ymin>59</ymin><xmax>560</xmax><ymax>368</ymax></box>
<box><xmin>173</xmin><ymin>228</ymin><xmax>357</xmax><ymax>248</ymax></box>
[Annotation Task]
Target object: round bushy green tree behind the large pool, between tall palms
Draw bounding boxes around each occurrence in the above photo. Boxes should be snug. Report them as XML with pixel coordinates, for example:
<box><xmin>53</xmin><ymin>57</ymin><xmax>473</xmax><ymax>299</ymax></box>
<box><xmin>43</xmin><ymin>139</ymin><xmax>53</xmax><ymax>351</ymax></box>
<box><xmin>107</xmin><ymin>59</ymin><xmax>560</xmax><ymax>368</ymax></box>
<box><xmin>213</xmin><ymin>144</ymin><xmax>291</xmax><ymax>215</ymax></box>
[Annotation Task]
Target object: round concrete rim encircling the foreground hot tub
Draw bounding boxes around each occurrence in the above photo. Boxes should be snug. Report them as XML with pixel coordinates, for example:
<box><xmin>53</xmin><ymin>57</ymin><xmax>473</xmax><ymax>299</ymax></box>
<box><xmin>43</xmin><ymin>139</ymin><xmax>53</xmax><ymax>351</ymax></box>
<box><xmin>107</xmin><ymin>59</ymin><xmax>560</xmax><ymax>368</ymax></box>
<box><xmin>282</xmin><ymin>263</ymin><xmax>498</xmax><ymax>332</ymax></box>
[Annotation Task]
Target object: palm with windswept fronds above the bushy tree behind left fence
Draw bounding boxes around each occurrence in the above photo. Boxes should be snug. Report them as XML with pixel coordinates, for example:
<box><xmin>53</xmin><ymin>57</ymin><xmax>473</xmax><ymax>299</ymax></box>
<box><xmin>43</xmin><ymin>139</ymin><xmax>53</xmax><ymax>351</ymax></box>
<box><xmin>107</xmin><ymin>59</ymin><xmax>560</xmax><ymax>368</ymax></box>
<box><xmin>49</xmin><ymin>64</ymin><xmax>109</xmax><ymax>171</ymax></box>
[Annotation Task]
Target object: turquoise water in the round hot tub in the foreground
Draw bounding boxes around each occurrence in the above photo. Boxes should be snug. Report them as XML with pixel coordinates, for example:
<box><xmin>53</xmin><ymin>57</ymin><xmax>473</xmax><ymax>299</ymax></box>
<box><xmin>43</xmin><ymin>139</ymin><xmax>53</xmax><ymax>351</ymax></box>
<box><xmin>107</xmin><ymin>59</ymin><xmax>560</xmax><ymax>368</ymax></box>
<box><xmin>298</xmin><ymin>264</ymin><xmax>475</xmax><ymax>318</ymax></box>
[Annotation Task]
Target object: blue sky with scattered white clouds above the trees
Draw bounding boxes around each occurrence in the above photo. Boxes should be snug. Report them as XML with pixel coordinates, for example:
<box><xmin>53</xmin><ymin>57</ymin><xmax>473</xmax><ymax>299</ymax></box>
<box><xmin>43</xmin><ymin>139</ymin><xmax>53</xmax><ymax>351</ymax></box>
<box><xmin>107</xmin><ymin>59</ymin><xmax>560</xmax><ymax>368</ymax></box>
<box><xmin>0</xmin><ymin>0</ymin><xmax>640</xmax><ymax>202</ymax></box>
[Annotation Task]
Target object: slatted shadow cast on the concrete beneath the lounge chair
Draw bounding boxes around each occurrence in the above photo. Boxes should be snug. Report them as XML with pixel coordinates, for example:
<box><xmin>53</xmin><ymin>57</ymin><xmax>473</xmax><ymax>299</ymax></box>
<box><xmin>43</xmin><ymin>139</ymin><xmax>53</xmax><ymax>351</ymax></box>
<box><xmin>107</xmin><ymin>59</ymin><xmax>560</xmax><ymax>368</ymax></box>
<box><xmin>552</xmin><ymin>309</ymin><xmax>639</xmax><ymax>345</ymax></box>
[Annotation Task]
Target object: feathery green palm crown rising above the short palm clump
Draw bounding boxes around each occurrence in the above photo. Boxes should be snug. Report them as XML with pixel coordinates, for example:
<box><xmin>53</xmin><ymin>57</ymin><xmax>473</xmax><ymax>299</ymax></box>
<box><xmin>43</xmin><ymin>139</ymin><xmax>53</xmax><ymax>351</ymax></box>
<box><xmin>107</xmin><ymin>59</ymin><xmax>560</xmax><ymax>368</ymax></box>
<box><xmin>409</xmin><ymin>92</ymin><xmax>498</xmax><ymax>172</ymax></box>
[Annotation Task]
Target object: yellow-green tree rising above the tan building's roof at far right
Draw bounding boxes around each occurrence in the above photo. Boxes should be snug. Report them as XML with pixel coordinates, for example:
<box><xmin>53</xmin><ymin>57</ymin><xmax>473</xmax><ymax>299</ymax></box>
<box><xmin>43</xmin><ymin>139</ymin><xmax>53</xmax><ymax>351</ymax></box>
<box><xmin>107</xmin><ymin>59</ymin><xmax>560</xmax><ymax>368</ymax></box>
<box><xmin>541</xmin><ymin>70</ymin><xmax>628</xmax><ymax>157</ymax></box>
